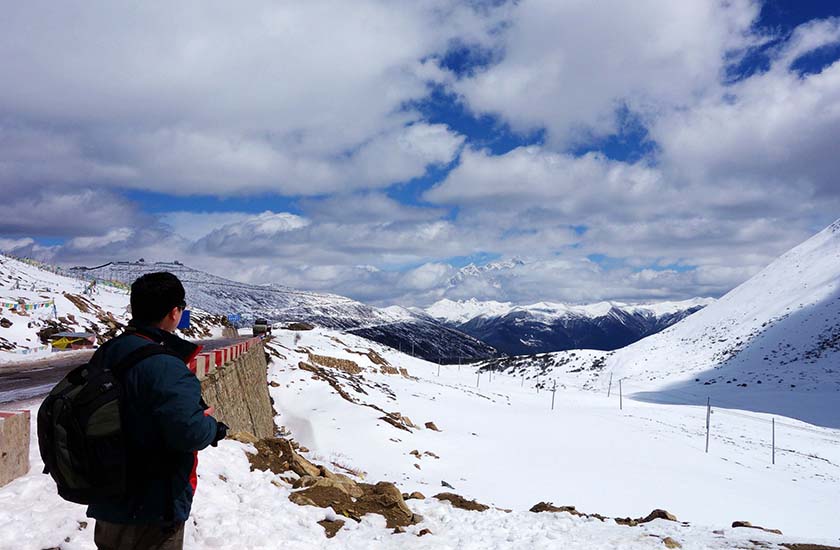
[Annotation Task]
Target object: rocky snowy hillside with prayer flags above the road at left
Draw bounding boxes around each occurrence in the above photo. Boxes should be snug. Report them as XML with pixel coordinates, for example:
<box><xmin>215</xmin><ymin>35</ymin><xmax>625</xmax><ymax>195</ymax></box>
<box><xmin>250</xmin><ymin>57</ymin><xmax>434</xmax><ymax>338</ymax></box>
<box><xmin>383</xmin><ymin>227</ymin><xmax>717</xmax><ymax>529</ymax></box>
<box><xmin>0</xmin><ymin>255</ymin><xmax>226</xmax><ymax>363</ymax></box>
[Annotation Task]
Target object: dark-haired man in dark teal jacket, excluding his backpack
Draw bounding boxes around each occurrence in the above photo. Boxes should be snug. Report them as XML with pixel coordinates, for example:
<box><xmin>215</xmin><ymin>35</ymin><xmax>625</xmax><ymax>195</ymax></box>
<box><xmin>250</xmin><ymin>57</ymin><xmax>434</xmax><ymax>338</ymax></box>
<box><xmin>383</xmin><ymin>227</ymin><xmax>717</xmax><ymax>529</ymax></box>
<box><xmin>87</xmin><ymin>273</ymin><xmax>228</xmax><ymax>550</ymax></box>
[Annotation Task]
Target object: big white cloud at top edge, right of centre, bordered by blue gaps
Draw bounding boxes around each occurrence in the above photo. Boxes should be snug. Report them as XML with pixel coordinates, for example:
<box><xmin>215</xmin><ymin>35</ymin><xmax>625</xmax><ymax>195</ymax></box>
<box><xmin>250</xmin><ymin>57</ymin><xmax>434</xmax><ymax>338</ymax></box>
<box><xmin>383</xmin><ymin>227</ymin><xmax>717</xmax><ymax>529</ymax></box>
<box><xmin>452</xmin><ymin>0</ymin><xmax>758</xmax><ymax>145</ymax></box>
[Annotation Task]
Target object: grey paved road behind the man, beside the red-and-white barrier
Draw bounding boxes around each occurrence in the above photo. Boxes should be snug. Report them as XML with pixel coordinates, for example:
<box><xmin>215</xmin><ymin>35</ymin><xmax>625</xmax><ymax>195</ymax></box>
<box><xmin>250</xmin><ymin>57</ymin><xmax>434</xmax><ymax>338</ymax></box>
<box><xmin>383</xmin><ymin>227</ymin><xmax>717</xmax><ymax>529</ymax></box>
<box><xmin>0</xmin><ymin>337</ymin><xmax>247</xmax><ymax>408</ymax></box>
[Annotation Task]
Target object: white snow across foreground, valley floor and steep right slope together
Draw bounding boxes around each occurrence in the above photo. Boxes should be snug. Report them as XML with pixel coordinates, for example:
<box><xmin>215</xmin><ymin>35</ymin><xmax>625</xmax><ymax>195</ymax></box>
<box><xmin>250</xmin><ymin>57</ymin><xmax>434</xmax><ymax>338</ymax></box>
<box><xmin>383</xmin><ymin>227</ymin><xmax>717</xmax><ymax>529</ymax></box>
<box><xmin>0</xmin><ymin>223</ymin><xmax>840</xmax><ymax>550</ymax></box>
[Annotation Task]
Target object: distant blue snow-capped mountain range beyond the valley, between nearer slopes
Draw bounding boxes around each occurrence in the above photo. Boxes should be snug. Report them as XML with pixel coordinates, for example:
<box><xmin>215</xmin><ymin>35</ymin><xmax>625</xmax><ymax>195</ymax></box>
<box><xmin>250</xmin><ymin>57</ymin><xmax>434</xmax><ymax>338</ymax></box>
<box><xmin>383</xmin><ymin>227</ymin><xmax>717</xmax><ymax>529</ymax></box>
<box><xmin>426</xmin><ymin>298</ymin><xmax>714</xmax><ymax>355</ymax></box>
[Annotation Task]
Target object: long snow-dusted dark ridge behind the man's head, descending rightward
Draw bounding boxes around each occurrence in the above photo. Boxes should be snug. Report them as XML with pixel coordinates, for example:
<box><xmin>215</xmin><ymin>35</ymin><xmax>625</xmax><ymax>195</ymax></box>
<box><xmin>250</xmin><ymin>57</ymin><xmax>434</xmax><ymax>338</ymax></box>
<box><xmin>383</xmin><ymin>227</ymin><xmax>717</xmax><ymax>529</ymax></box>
<box><xmin>71</xmin><ymin>261</ymin><xmax>496</xmax><ymax>361</ymax></box>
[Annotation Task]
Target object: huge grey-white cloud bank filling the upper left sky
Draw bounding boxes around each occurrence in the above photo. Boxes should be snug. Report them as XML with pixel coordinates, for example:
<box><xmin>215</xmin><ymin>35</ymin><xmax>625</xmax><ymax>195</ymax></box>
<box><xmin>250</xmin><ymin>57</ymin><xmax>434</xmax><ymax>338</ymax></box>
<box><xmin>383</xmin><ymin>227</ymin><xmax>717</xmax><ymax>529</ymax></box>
<box><xmin>0</xmin><ymin>0</ymin><xmax>488</xmax><ymax>195</ymax></box>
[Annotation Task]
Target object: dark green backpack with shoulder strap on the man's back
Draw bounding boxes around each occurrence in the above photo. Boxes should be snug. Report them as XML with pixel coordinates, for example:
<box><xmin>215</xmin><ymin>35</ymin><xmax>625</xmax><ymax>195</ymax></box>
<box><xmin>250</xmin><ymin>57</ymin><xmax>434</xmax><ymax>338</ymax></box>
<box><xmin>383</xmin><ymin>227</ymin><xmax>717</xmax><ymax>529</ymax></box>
<box><xmin>38</xmin><ymin>337</ymin><xmax>174</xmax><ymax>504</ymax></box>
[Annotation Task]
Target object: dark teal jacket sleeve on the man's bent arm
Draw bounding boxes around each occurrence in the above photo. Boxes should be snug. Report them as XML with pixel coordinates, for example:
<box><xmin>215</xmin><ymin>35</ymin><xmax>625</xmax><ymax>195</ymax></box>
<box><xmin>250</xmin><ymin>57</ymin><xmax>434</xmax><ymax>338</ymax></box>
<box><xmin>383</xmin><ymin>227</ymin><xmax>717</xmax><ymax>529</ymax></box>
<box><xmin>148</xmin><ymin>356</ymin><xmax>216</xmax><ymax>452</ymax></box>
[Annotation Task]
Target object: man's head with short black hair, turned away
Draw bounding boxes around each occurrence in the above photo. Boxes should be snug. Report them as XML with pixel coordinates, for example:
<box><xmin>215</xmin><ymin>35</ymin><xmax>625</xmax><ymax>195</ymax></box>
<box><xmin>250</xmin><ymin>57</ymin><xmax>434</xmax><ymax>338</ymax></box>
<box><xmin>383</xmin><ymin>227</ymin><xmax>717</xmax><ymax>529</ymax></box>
<box><xmin>131</xmin><ymin>271</ymin><xmax>187</xmax><ymax>332</ymax></box>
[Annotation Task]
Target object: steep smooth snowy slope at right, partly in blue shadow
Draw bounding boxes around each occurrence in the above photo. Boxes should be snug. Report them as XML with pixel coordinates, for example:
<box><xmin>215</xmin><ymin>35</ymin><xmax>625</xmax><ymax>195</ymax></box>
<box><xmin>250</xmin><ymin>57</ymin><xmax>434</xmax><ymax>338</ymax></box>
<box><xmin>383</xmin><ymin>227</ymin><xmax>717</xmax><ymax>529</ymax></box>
<box><xmin>602</xmin><ymin>220</ymin><xmax>840</xmax><ymax>428</ymax></box>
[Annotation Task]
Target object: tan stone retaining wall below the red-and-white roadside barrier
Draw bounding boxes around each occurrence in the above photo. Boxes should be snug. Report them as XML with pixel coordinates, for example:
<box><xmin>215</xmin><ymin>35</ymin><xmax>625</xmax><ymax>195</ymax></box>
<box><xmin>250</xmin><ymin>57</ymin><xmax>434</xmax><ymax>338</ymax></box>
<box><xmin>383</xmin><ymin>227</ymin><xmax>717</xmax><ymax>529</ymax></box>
<box><xmin>199</xmin><ymin>339</ymin><xmax>274</xmax><ymax>438</ymax></box>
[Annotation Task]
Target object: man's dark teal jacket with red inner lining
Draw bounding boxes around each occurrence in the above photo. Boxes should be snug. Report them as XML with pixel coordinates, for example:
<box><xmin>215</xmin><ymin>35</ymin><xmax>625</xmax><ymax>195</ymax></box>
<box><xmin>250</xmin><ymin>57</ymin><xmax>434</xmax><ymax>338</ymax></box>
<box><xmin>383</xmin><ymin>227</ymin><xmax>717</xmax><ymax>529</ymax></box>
<box><xmin>87</xmin><ymin>327</ymin><xmax>216</xmax><ymax>524</ymax></box>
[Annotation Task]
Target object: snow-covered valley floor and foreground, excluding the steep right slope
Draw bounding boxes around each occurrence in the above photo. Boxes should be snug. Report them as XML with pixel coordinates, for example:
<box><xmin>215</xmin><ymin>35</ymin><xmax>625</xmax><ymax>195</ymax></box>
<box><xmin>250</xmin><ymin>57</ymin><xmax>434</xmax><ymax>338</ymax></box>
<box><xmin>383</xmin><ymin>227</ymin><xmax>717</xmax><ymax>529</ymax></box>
<box><xmin>6</xmin><ymin>329</ymin><xmax>840</xmax><ymax>550</ymax></box>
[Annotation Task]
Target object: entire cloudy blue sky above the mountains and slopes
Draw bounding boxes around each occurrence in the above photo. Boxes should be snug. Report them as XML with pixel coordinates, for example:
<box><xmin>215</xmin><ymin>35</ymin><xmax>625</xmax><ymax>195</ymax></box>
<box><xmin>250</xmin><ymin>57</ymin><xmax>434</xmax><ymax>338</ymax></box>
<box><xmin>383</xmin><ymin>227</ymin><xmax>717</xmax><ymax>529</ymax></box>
<box><xmin>0</xmin><ymin>0</ymin><xmax>840</xmax><ymax>306</ymax></box>
